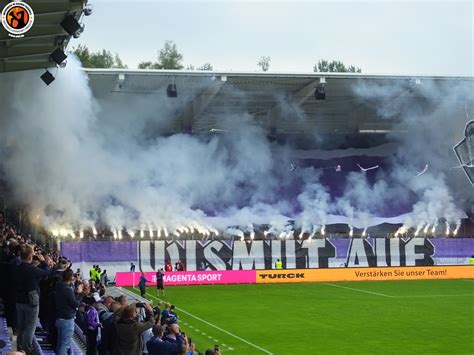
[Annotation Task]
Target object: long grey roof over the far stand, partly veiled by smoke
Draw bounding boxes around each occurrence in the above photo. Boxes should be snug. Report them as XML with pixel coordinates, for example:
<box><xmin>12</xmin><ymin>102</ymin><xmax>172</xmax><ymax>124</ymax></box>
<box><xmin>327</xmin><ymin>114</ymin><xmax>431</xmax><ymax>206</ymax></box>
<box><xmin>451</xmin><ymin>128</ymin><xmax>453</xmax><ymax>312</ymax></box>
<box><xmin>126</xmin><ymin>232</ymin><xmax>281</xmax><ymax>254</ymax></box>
<box><xmin>86</xmin><ymin>69</ymin><xmax>474</xmax><ymax>139</ymax></box>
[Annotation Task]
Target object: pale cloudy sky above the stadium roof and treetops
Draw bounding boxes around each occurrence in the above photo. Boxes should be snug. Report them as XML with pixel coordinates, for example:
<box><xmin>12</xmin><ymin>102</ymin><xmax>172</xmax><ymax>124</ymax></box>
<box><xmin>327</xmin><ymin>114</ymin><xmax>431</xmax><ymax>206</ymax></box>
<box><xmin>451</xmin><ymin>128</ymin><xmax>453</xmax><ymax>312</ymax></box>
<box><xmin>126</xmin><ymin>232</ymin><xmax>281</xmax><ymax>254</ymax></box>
<box><xmin>76</xmin><ymin>0</ymin><xmax>474</xmax><ymax>76</ymax></box>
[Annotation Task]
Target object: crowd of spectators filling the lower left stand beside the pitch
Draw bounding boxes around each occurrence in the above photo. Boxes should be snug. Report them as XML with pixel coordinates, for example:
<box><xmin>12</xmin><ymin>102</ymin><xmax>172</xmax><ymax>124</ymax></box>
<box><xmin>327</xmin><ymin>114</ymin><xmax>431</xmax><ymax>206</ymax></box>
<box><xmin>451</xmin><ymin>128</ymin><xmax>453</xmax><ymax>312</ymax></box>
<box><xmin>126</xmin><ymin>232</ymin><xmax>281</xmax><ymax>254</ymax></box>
<box><xmin>0</xmin><ymin>214</ymin><xmax>219</xmax><ymax>355</ymax></box>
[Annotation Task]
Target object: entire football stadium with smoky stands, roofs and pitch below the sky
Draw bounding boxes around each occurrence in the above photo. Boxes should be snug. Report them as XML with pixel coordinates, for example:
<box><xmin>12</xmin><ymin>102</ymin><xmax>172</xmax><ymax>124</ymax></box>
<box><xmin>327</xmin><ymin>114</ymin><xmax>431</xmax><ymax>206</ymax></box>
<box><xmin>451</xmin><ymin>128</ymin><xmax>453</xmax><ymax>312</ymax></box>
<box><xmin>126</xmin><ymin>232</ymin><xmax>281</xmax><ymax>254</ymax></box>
<box><xmin>0</xmin><ymin>1</ymin><xmax>474</xmax><ymax>355</ymax></box>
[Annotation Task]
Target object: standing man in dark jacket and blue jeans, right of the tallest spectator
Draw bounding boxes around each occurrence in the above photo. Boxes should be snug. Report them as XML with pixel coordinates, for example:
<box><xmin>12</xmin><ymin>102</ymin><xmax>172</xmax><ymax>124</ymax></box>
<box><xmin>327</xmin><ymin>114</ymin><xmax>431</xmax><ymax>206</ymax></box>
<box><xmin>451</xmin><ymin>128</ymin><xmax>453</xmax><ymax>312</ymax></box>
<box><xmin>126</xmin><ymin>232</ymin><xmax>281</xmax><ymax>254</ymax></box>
<box><xmin>55</xmin><ymin>269</ymin><xmax>83</xmax><ymax>355</ymax></box>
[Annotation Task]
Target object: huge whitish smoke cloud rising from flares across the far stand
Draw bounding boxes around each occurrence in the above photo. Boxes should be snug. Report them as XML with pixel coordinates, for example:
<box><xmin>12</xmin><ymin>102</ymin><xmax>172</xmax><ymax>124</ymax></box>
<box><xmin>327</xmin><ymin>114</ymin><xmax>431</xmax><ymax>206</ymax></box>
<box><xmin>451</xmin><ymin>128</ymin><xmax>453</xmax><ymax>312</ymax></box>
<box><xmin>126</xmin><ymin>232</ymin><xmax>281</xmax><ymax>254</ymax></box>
<box><xmin>0</xmin><ymin>59</ymin><xmax>474</xmax><ymax>238</ymax></box>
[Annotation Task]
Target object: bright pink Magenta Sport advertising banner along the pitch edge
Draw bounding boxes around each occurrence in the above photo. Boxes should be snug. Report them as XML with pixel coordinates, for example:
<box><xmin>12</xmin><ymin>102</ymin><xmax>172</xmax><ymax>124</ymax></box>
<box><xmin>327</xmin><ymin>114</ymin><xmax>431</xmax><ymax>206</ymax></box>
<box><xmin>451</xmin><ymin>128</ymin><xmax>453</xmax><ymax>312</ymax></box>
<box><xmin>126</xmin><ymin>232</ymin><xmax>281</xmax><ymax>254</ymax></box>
<box><xmin>116</xmin><ymin>270</ymin><xmax>256</xmax><ymax>286</ymax></box>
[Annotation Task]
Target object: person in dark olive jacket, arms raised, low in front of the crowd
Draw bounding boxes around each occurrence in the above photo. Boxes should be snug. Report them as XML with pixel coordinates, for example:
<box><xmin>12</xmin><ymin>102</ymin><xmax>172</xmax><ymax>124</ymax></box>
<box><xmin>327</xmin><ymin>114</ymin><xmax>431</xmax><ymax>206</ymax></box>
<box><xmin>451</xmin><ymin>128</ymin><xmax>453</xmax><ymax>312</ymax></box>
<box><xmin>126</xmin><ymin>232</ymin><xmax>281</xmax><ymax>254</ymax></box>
<box><xmin>114</xmin><ymin>303</ymin><xmax>155</xmax><ymax>355</ymax></box>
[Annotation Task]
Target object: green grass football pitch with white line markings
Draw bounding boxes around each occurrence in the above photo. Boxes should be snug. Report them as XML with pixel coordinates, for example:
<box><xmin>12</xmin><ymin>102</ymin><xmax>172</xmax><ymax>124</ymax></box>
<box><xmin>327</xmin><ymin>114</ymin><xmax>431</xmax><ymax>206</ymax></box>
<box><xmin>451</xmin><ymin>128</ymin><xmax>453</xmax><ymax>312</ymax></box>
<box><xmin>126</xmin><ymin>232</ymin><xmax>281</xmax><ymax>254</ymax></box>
<box><xmin>130</xmin><ymin>279</ymin><xmax>474</xmax><ymax>355</ymax></box>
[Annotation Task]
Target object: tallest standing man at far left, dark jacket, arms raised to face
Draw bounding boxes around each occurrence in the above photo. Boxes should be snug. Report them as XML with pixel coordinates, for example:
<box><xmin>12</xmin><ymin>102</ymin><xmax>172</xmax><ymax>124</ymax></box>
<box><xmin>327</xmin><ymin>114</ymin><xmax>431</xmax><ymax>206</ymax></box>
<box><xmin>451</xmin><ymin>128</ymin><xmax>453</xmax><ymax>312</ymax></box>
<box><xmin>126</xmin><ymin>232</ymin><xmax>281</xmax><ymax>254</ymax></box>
<box><xmin>15</xmin><ymin>245</ymin><xmax>50</xmax><ymax>354</ymax></box>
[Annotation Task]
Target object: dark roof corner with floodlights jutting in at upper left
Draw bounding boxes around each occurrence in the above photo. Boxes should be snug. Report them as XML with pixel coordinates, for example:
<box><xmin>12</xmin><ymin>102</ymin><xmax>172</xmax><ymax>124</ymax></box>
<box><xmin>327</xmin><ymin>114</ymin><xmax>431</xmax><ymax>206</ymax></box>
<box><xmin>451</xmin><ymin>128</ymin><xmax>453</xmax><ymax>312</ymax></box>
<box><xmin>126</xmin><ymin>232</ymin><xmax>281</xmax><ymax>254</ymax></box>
<box><xmin>0</xmin><ymin>0</ymin><xmax>86</xmax><ymax>72</ymax></box>
